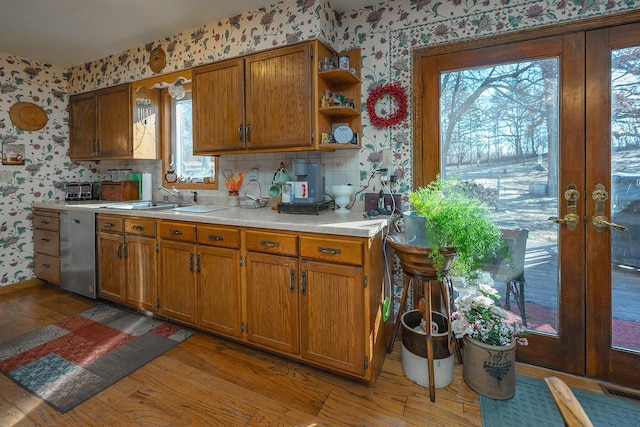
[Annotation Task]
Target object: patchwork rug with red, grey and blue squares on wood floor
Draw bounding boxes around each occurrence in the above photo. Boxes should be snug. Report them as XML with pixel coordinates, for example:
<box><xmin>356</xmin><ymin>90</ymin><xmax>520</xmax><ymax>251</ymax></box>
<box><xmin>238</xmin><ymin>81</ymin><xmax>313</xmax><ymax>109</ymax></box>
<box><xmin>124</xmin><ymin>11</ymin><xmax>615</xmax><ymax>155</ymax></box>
<box><xmin>0</xmin><ymin>305</ymin><xmax>193</xmax><ymax>413</ymax></box>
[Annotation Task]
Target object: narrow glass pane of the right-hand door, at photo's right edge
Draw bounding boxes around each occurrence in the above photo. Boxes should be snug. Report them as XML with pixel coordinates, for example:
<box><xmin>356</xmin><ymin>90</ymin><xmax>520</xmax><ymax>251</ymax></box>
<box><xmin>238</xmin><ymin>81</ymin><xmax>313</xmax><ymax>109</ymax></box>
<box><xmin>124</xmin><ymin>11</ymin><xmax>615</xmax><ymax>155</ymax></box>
<box><xmin>611</xmin><ymin>47</ymin><xmax>640</xmax><ymax>350</ymax></box>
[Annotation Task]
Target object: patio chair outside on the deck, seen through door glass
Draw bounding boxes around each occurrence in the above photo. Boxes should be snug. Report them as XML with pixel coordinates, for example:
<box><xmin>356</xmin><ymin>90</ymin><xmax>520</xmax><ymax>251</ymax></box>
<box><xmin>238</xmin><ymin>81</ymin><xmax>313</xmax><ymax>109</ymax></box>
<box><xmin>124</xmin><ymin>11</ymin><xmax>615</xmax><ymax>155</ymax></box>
<box><xmin>482</xmin><ymin>228</ymin><xmax>529</xmax><ymax>326</ymax></box>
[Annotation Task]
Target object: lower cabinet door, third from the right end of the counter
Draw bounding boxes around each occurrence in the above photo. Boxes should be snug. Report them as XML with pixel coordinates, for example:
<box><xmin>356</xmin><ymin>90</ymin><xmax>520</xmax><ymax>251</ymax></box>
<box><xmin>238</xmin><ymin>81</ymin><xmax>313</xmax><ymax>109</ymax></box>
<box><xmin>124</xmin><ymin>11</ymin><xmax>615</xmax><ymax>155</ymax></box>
<box><xmin>196</xmin><ymin>245</ymin><xmax>242</xmax><ymax>337</ymax></box>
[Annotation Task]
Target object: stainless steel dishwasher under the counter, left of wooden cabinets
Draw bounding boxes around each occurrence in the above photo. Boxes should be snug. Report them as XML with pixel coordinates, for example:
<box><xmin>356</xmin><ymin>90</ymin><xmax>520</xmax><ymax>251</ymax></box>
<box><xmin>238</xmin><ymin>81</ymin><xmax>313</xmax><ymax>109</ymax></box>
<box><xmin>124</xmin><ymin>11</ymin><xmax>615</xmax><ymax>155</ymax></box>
<box><xmin>60</xmin><ymin>211</ymin><xmax>98</xmax><ymax>299</ymax></box>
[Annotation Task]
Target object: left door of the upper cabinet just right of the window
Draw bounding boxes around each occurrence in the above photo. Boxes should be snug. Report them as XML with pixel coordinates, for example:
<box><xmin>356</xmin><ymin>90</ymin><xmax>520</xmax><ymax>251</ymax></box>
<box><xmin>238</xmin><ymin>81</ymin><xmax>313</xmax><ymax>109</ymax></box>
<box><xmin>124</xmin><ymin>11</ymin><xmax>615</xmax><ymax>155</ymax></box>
<box><xmin>192</xmin><ymin>59</ymin><xmax>245</xmax><ymax>153</ymax></box>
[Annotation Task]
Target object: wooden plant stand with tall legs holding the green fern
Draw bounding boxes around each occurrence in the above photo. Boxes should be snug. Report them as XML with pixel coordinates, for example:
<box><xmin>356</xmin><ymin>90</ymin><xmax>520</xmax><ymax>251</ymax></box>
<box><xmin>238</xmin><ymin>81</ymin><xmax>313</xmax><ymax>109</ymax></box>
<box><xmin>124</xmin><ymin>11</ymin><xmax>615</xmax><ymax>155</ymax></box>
<box><xmin>387</xmin><ymin>233</ymin><xmax>456</xmax><ymax>402</ymax></box>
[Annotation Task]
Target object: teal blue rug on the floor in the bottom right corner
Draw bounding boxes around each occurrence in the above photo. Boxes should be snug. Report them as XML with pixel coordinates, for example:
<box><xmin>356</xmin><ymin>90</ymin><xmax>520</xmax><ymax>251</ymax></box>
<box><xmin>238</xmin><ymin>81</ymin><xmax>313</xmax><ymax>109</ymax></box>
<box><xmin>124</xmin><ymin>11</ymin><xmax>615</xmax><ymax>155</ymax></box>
<box><xmin>480</xmin><ymin>375</ymin><xmax>640</xmax><ymax>427</ymax></box>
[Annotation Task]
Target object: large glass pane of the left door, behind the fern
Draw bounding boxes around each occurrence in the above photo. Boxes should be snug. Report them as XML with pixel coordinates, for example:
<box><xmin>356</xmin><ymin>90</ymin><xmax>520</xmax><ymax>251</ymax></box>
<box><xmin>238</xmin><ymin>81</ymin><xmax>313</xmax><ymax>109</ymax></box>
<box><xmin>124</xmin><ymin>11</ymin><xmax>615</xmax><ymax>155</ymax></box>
<box><xmin>440</xmin><ymin>57</ymin><xmax>564</xmax><ymax>335</ymax></box>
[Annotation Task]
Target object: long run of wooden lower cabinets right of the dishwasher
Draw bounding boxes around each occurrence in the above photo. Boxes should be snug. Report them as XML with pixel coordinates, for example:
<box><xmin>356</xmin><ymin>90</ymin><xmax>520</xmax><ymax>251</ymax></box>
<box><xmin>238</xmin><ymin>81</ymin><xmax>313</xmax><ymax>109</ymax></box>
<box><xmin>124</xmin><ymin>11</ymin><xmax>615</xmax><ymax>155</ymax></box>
<box><xmin>98</xmin><ymin>215</ymin><xmax>393</xmax><ymax>383</ymax></box>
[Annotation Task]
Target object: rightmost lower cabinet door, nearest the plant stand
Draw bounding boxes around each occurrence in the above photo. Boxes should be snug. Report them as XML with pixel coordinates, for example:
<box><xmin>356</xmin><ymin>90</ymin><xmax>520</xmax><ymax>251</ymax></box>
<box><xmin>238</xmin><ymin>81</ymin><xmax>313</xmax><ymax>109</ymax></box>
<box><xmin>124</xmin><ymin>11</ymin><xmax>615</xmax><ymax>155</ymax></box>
<box><xmin>300</xmin><ymin>261</ymin><xmax>365</xmax><ymax>375</ymax></box>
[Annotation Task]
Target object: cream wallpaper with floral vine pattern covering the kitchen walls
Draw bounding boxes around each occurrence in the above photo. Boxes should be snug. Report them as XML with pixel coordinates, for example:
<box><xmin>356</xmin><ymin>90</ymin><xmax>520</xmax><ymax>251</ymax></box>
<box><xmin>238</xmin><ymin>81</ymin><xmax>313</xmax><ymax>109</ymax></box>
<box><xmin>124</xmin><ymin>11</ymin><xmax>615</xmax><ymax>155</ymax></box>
<box><xmin>0</xmin><ymin>0</ymin><xmax>640</xmax><ymax>285</ymax></box>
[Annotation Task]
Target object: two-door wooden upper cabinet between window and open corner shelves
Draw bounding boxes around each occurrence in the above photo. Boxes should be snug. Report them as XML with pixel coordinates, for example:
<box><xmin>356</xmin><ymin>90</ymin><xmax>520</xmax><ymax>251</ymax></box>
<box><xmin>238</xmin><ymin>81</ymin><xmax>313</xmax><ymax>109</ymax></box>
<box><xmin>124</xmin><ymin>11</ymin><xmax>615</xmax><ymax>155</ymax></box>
<box><xmin>193</xmin><ymin>42</ymin><xmax>314</xmax><ymax>154</ymax></box>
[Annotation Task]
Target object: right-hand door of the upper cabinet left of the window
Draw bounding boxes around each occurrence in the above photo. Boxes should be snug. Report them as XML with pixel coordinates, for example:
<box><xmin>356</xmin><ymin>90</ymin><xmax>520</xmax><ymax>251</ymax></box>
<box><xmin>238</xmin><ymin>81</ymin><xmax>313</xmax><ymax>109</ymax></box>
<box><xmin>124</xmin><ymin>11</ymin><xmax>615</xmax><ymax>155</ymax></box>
<box><xmin>96</xmin><ymin>84</ymin><xmax>133</xmax><ymax>158</ymax></box>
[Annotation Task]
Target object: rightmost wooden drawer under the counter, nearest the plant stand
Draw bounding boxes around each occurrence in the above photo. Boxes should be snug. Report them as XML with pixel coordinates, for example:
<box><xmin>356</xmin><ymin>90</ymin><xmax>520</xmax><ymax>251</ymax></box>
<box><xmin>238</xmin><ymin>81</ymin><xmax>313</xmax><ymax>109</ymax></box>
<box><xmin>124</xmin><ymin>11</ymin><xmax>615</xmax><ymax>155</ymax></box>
<box><xmin>300</xmin><ymin>236</ymin><xmax>364</xmax><ymax>265</ymax></box>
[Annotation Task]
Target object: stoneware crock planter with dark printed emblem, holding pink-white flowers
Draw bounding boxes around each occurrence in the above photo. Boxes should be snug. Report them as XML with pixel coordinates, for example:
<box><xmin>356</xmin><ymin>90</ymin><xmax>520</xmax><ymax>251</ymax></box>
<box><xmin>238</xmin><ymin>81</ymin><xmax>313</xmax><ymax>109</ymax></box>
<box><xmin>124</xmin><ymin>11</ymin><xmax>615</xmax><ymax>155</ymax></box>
<box><xmin>462</xmin><ymin>337</ymin><xmax>516</xmax><ymax>400</ymax></box>
